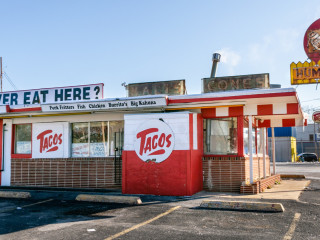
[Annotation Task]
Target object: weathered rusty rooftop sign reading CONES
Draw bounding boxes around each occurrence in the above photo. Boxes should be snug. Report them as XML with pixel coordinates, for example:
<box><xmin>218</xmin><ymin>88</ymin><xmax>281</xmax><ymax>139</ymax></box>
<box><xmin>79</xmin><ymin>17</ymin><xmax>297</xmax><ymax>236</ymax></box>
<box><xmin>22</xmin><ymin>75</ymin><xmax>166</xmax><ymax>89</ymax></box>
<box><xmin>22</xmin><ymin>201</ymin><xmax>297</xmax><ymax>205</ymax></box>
<box><xmin>202</xmin><ymin>73</ymin><xmax>270</xmax><ymax>93</ymax></box>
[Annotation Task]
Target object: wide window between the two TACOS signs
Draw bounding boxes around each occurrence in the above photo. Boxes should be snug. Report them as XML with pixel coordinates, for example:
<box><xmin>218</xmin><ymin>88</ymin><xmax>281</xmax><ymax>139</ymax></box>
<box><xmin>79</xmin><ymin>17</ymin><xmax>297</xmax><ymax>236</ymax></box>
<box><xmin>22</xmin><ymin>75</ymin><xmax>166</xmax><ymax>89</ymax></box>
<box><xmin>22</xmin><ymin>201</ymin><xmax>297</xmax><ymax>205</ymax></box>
<box><xmin>72</xmin><ymin>121</ymin><xmax>123</xmax><ymax>157</ymax></box>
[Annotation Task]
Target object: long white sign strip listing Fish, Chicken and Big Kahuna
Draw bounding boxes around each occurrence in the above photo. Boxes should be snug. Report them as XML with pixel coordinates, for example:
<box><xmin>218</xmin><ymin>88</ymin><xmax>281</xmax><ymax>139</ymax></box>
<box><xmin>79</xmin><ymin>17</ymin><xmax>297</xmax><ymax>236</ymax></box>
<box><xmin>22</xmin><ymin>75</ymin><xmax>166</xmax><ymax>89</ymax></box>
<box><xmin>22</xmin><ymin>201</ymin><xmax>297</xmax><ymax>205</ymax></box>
<box><xmin>41</xmin><ymin>97</ymin><xmax>167</xmax><ymax>112</ymax></box>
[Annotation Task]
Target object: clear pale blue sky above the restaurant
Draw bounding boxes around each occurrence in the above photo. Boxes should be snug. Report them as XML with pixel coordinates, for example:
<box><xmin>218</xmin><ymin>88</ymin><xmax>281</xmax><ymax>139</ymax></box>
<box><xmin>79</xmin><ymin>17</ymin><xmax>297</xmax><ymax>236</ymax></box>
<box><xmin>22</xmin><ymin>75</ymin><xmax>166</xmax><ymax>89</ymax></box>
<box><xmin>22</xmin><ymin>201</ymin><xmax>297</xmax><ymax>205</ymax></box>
<box><xmin>0</xmin><ymin>0</ymin><xmax>320</xmax><ymax>111</ymax></box>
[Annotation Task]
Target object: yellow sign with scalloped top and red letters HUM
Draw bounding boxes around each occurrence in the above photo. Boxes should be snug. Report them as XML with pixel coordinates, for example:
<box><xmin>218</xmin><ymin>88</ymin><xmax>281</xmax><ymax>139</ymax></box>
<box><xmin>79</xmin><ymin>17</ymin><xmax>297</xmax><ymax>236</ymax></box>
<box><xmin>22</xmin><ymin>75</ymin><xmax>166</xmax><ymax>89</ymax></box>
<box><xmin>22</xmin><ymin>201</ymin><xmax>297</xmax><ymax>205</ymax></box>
<box><xmin>290</xmin><ymin>61</ymin><xmax>320</xmax><ymax>85</ymax></box>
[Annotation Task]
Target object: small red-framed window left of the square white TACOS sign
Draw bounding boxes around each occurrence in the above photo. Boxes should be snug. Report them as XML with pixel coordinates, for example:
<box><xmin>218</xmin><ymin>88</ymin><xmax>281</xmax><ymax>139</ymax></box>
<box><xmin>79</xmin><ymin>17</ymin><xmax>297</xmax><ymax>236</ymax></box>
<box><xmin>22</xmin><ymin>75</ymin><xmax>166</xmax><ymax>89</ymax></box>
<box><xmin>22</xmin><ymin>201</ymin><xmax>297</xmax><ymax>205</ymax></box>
<box><xmin>14</xmin><ymin>124</ymin><xmax>31</xmax><ymax>154</ymax></box>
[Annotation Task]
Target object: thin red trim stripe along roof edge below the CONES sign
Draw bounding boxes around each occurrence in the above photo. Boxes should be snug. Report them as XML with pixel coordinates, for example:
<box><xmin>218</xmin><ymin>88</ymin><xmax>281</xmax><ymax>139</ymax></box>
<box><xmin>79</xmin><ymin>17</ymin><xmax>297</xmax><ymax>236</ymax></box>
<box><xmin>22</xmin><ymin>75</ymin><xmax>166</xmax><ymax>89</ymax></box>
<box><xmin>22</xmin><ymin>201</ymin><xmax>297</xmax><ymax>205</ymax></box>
<box><xmin>169</xmin><ymin>92</ymin><xmax>296</xmax><ymax>104</ymax></box>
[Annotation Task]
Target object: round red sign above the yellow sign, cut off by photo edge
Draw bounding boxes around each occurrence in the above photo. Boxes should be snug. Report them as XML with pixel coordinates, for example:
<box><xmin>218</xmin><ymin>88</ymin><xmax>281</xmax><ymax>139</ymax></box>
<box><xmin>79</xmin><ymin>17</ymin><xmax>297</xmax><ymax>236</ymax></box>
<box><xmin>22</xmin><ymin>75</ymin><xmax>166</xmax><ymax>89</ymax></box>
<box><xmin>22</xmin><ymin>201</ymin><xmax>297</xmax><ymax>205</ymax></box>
<box><xmin>303</xmin><ymin>19</ymin><xmax>320</xmax><ymax>63</ymax></box>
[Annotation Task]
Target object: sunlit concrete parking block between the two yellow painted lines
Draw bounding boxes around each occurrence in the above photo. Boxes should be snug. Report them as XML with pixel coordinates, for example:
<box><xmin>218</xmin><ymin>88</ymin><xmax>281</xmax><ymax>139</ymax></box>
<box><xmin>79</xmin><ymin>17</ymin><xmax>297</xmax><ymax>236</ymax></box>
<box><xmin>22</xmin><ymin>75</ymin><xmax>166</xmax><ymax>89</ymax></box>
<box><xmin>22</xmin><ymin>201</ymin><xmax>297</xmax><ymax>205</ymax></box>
<box><xmin>200</xmin><ymin>200</ymin><xmax>284</xmax><ymax>212</ymax></box>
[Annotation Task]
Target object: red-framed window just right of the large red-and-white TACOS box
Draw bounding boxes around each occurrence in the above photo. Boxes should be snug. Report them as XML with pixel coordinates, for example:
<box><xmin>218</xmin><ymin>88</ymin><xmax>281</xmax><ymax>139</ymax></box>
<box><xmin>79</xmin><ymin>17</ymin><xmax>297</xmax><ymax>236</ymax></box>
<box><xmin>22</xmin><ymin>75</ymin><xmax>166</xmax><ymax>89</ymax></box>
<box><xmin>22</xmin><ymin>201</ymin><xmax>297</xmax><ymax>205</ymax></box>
<box><xmin>205</xmin><ymin>118</ymin><xmax>238</xmax><ymax>155</ymax></box>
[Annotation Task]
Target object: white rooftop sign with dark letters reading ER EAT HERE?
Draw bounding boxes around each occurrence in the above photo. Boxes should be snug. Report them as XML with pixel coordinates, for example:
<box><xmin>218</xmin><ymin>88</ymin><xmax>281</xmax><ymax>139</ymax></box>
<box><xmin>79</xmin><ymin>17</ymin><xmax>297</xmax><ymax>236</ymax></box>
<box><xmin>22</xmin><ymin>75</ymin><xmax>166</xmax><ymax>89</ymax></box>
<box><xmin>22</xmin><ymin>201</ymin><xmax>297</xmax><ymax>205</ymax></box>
<box><xmin>0</xmin><ymin>83</ymin><xmax>103</xmax><ymax>106</ymax></box>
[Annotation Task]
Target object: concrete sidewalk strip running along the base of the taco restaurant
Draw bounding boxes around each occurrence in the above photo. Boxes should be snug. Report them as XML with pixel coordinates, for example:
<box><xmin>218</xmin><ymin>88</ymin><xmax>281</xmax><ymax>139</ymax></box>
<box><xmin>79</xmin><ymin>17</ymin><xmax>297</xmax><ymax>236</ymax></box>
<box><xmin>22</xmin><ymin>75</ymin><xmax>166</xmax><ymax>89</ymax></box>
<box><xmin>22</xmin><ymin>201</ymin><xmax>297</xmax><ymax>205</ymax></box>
<box><xmin>0</xmin><ymin>180</ymin><xmax>310</xmax><ymax>204</ymax></box>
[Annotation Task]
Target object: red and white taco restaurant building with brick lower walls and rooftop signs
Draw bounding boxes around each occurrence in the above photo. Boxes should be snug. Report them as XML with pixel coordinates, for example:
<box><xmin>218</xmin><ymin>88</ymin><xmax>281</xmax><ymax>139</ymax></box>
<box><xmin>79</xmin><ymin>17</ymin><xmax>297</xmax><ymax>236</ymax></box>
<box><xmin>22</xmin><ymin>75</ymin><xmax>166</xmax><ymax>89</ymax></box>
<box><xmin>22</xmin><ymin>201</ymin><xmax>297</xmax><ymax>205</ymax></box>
<box><xmin>0</xmin><ymin>71</ymin><xmax>306</xmax><ymax>196</ymax></box>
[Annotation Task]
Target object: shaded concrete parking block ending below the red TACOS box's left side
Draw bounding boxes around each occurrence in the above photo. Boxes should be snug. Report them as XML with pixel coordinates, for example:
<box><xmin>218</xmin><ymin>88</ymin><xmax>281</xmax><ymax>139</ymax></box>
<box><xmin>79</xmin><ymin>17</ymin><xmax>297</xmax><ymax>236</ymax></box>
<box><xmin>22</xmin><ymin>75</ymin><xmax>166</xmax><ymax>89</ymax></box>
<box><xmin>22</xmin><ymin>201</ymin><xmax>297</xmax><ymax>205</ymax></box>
<box><xmin>76</xmin><ymin>194</ymin><xmax>142</xmax><ymax>205</ymax></box>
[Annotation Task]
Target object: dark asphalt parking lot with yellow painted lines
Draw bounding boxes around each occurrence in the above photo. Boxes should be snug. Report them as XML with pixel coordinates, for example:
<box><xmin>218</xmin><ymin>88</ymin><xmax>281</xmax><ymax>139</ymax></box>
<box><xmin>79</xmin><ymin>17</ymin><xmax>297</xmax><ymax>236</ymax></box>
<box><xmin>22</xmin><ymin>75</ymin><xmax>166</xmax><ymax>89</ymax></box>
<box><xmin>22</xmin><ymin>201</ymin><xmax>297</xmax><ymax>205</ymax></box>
<box><xmin>0</xmin><ymin>164</ymin><xmax>320</xmax><ymax>240</ymax></box>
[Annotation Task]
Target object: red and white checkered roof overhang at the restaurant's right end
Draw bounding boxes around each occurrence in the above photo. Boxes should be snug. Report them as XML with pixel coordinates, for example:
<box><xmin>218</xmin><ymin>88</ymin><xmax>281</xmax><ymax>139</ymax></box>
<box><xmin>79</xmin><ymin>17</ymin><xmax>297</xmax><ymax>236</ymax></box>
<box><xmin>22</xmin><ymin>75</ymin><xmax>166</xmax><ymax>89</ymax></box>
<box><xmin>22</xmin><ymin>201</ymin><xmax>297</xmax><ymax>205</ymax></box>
<box><xmin>168</xmin><ymin>88</ymin><xmax>307</xmax><ymax>127</ymax></box>
